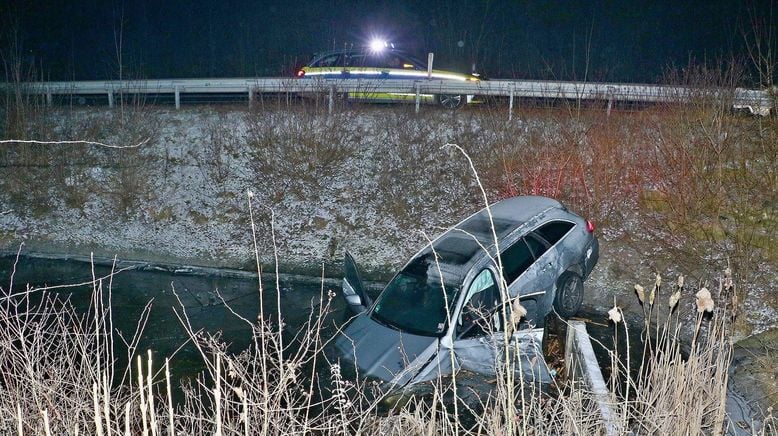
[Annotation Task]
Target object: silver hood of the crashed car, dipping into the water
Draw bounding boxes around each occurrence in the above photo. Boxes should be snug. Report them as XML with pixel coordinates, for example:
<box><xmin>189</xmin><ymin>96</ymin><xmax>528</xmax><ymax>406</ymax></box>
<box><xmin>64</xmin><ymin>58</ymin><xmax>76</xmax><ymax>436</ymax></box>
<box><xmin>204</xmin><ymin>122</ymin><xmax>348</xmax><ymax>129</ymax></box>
<box><xmin>335</xmin><ymin>313</ymin><xmax>438</xmax><ymax>384</ymax></box>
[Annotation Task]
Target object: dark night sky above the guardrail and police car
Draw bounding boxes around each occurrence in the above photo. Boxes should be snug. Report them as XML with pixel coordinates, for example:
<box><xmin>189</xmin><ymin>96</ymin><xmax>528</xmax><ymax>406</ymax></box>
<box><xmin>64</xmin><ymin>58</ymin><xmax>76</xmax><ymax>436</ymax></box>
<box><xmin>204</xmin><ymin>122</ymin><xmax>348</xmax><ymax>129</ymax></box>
<box><xmin>0</xmin><ymin>0</ymin><xmax>776</xmax><ymax>82</ymax></box>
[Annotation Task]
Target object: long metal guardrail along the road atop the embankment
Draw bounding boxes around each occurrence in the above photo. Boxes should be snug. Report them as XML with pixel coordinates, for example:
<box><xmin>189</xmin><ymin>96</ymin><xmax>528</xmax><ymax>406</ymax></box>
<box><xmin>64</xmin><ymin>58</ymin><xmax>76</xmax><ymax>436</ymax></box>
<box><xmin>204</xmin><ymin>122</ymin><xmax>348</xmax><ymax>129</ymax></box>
<box><xmin>0</xmin><ymin>77</ymin><xmax>775</xmax><ymax>115</ymax></box>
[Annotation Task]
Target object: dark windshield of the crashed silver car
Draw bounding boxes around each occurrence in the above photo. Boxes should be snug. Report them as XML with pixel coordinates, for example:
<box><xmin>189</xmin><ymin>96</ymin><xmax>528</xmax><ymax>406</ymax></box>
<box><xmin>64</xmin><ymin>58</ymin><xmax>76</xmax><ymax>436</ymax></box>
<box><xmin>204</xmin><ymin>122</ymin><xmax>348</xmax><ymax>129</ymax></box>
<box><xmin>372</xmin><ymin>256</ymin><xmax>459</xmax><ymax>336</ymax></box>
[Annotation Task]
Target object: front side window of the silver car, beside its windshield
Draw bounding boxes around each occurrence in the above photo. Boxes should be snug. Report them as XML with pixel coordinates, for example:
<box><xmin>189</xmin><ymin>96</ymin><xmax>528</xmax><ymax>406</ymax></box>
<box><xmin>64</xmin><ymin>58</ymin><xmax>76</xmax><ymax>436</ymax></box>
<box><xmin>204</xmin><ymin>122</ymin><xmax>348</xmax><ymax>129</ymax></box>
<box><xmin>457</xmin><ymin>269</ymin><xmax>501</xmax><ymax>339</ymax></box>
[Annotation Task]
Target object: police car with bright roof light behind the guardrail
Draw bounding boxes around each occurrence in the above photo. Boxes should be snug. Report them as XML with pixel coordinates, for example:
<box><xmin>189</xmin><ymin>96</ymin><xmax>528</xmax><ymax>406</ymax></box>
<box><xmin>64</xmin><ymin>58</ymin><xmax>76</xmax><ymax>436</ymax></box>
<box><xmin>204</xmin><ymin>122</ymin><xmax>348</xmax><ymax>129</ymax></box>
<box><xmin>296</xmin><ymin>41</ymin><xmax>481</xmax><ymax>109</ymax></box>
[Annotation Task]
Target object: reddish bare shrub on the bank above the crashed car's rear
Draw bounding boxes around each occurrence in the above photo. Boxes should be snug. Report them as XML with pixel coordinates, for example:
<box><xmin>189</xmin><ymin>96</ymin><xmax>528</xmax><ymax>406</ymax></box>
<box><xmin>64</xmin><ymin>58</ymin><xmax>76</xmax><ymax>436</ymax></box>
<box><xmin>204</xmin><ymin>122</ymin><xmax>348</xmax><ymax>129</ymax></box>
<box><xmin>476</xmin><ymin>110</ymin><xmax>643</xmax><ymax>227</ymax></box>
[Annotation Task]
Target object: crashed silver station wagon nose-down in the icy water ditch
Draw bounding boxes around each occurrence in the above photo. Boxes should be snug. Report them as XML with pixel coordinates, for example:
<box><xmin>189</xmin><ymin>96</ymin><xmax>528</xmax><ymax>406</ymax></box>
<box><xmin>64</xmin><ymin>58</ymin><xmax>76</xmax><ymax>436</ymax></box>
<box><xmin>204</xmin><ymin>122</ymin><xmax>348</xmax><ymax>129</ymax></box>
<box><xmin>334</xmin><ymin>196</ymin><xmax>599</xmax><ymax>392</ymax></box>
